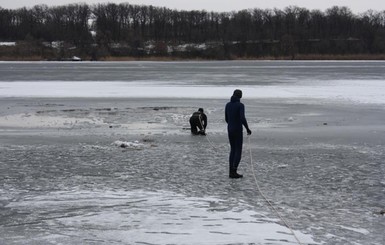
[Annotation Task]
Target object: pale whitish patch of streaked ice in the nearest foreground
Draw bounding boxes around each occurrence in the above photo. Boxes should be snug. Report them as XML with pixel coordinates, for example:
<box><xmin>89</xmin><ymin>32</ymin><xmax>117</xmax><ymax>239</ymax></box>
<box><xmin>6</xmin><ymin>190</ymin><xmax>315</xmax><ymax>244</ymax></box>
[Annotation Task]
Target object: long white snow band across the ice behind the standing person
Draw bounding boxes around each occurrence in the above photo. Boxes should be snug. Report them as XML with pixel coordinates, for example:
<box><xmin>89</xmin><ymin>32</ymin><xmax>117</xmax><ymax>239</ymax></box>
<box><xmin>0</xmin><ymin>80</ymin><xmax>385</xmax><ymax>104</ymax></box>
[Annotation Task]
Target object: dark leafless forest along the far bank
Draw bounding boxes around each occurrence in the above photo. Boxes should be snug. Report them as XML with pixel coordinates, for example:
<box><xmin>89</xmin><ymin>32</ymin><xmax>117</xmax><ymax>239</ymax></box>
<box><xmin>0</xmin><ymin>3</ymin><xmax>385</xmax><ymax>60</ymax></box>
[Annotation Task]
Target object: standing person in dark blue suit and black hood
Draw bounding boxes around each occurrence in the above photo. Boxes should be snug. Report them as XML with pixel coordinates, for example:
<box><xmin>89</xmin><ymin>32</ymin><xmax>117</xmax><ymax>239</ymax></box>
<box><xmin>225</xmin><ymin>89</ymin><xmax>251</xmax><ymax>179</ymax></box>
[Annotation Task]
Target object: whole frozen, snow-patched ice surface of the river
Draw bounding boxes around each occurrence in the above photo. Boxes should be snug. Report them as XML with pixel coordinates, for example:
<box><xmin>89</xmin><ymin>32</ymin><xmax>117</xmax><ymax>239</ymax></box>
<box><xmin>0</xmin><ymin>61</ymin><xmax>385</xmax><ymax>245</ymax></box>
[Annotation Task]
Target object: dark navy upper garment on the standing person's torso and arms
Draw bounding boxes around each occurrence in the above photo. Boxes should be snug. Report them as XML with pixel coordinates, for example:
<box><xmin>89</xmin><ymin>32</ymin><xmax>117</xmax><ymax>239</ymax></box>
<box><xmin>225</xmin><ymin>96</ymin><xmax>249</xmax><ymax>133</ymax></box>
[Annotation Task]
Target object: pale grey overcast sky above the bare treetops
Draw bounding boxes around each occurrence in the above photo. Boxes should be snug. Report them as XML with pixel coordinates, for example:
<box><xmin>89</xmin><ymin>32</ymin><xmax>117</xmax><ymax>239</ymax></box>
<box><xmin>0</xmin><ymin>0</ymin><xmax>385</xmax><ymax>13</ymax></box>
